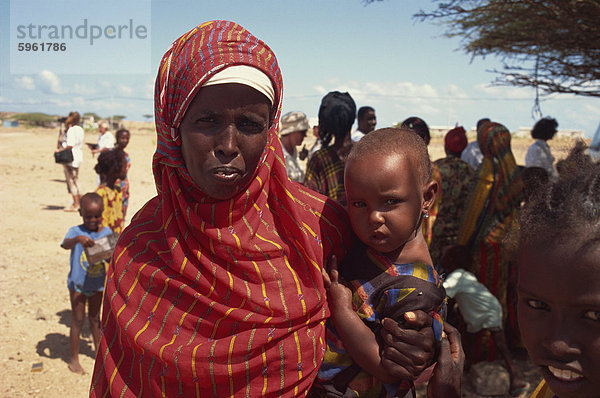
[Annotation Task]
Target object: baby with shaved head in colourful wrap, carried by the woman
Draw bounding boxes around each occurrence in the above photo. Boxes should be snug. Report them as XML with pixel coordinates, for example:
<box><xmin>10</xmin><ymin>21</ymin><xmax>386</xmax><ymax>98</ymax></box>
<box><xmin>317</xmin><ymin>128</ymin><xmax>446</xmax><ymax>396</ymax></box>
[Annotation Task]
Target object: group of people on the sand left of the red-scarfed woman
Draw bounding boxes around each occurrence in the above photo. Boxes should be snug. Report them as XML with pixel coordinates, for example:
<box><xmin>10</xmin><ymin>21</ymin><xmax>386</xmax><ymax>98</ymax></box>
<box><xmin>57</xmin><ymin>112</ymin><xmax>130</xmax><ymax>373</ymax></box>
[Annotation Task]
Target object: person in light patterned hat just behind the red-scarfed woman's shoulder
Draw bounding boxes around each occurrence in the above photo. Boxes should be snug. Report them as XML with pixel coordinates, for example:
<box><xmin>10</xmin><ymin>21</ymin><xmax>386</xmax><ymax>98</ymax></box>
<box><xmin>279</xmin><ymin>112</ymin><xmax>310</xmax><ymax>183</ymax></box>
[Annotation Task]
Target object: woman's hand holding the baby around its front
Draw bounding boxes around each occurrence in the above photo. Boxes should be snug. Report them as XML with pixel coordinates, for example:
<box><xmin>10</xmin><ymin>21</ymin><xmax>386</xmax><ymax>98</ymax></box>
<box><xmin>381</xmin><ymin>311</ymin><xmax>436</xmax><ymax>381</ymax></box>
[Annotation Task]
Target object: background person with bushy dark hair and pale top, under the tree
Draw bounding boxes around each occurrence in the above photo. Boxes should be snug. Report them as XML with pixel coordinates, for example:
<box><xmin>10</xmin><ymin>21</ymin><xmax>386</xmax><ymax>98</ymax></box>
<box><xmin>525</xmin><ymin>117</ymin><xmax>558</xmax><ymax>179</ymax></box>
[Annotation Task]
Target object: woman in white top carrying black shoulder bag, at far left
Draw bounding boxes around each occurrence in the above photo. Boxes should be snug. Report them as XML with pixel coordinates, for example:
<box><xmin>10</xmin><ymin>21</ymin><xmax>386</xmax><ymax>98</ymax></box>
<box><xmin>61</xmin><ymin>112</ymin><xmax>84</xmax><ymax>211</ymax></box>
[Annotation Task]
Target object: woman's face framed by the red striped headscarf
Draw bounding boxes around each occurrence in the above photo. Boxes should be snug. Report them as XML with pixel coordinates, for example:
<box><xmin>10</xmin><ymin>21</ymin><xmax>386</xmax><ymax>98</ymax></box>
<box><xmin>179</xmin><ymin>83</ymin><xmax>271</xmax><ymax>199</ymax></box>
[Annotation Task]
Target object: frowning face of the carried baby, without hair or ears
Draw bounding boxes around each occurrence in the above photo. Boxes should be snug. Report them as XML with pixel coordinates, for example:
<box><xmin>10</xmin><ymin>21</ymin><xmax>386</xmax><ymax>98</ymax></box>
<box><xmin>345</xmin><ymin>154</ymin><xmax>424</xmax><ymax>262</ymax></box>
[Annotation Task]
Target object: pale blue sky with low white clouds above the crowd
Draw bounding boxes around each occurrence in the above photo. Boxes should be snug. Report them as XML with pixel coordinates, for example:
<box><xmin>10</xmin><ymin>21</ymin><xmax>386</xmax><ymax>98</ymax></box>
<box><xmin>0</xmin><ymin>0</ymin><xmax>600</xmax><ymax>137</ymax></box>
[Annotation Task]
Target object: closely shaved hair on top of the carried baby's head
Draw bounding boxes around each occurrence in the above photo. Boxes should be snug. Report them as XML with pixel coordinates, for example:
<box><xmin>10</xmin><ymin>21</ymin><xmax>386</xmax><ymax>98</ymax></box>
<box><xmin>347</xmin><ymin>128</ymin><xmax>432</xmax><ymax>183</ymax></box>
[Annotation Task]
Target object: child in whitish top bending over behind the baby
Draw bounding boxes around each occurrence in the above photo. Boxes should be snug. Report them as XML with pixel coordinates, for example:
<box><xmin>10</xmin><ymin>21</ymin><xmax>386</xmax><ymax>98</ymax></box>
<box><xmin>440</xmin><ymin>245</ymin><xmax>527</xmax><ymax>397</ymax></box>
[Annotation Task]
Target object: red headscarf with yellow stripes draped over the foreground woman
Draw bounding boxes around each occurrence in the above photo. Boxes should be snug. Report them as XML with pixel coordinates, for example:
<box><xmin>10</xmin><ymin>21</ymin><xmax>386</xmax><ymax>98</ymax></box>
<box><xmin>91</xmin><ymin>21</ymin><xmax>350</xmax><ymax>397</ymax></box>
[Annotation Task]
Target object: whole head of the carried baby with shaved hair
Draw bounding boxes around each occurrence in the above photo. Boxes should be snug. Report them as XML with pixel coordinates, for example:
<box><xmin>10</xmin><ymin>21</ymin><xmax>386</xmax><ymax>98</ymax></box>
<box><xmin>344</xmin><ymin>128</ymin><xmax>437</xmax><ymax>261</ymax></box>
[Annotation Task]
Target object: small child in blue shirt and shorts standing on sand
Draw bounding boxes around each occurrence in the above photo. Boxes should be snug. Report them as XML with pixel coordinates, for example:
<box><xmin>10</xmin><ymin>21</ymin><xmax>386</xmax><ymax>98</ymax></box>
<box><xmin>61</xmin><ymin>192</ymin><xmax>112</xmax><ymax>374</ymax></box>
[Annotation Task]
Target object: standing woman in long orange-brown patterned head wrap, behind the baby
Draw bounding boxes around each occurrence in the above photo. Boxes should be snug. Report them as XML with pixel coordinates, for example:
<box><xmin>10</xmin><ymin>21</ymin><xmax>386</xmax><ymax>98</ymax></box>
<box><xmin>457</xmin><ymin>122</ymin><xmax>523</xmax><ymax>356</ymax></box>
